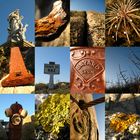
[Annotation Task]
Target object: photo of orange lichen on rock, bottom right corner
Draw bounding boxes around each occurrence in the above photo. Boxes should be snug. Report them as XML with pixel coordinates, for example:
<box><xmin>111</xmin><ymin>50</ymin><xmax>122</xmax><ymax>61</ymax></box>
<box><xmin>105</xmin><ymin>93</ymin><xmax>140</xmax><ymax>140</ymax></box>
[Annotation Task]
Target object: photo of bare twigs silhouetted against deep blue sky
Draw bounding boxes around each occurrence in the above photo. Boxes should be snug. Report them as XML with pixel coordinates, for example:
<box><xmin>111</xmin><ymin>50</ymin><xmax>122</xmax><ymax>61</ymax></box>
<box><xmin>105</xmin><ymin>47</ymin><xmax>140</xmax><ymax>93</ymax></box>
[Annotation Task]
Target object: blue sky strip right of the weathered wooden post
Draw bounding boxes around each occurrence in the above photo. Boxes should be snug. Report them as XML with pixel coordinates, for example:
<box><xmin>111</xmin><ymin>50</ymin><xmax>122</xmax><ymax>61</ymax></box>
<box><xmin>93</xmin><ymin>94</ymin><xmax>105</xmax><ymax>140</ymax></box>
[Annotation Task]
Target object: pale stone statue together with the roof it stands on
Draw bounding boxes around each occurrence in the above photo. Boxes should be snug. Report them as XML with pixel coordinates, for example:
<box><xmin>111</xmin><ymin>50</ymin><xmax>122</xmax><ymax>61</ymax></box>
<box><xmin>0</xmin><ymin>9</ymin><xmax>34</xmax><ymax>47</ymax></box>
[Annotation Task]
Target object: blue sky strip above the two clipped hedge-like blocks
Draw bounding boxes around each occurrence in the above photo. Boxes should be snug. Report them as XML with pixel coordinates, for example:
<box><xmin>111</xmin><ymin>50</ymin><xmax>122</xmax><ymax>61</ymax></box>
<box><xmin>70</xmin><ymin>0</ymin><xmax>105</xmax><ymax>12</ymax></box>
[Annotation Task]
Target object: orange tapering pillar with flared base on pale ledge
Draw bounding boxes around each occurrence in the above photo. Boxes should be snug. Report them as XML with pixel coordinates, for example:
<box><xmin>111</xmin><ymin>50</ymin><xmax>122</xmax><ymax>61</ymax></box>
<box><xmin>2</xmin><ymin>47</ymin><xmax>34</xmax><ymax>87</ymax></box>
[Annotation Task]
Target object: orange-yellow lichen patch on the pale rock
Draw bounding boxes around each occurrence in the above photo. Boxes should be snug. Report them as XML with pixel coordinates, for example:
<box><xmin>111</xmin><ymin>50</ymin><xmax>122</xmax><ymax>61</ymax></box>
<box><xmin>110</xmin><ymin>113</ymin><xmax>138</xmax><ymax>132</ymax></box>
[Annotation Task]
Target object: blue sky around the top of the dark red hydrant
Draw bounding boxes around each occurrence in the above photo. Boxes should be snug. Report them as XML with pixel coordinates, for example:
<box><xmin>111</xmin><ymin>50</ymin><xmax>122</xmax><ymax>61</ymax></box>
<box><xmin>0</xmin><ymin>94</ymin><xmax>35</xmax><ymax>121</ymax></box>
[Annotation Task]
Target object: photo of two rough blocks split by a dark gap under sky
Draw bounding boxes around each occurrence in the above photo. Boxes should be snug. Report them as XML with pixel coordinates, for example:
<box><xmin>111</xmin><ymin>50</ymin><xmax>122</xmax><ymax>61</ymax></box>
<box><xmin>70</xmin><ymin>0</ymin><xmax>105</xmax><ymax>47</ymax></box>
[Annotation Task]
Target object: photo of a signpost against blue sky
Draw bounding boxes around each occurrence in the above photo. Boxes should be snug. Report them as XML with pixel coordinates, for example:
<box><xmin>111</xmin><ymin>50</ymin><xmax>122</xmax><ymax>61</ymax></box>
<box><xmin>35</xmin><ymin>47</ymin><xmax>70</xmax><ymax>94</ymax></box>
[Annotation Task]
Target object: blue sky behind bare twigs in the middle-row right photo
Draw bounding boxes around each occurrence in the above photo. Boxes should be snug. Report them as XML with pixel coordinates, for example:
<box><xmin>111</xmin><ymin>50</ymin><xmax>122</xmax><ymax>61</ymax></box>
<box><xmin>106</xmin><ymin>47</ymin><xmax>140</xmax><ymax>86</ymax></box>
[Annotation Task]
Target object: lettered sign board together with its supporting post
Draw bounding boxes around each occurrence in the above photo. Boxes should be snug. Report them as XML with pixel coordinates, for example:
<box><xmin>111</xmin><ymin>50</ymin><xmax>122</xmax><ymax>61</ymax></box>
<box><xmin>44</xmin><ymin>62</ymin><xmax>60</xmax><ymax>89</ymax></box>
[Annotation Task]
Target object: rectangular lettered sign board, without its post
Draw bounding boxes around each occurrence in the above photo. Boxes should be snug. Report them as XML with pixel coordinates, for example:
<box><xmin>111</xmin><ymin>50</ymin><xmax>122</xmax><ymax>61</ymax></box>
<box><xmin>44</xmin><ymin>62</ymin><xmax>60</xmax><ymax>74</ymax></box>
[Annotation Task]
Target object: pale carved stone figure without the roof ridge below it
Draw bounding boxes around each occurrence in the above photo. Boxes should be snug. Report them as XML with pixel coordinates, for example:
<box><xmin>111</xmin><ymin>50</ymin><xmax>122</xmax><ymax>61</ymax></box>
<box><xmin>8</xmin><ymin>9</ymin><xmax>28</xmax><ymax>42</ymax></box>
